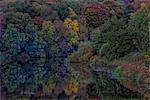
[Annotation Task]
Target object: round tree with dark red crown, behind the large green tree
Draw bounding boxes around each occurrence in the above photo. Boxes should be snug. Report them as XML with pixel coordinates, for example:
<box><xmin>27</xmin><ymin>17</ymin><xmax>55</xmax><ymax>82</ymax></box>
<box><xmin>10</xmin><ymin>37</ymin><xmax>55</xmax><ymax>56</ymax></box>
<box><xmin>82</xmin><ymin>3</ymin><xmax>109</xmax><ymax>28</ymax></box>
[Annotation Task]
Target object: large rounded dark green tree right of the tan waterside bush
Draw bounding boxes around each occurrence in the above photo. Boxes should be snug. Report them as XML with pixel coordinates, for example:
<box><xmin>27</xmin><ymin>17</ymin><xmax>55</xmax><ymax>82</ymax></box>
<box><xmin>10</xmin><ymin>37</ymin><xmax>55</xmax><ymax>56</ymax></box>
<box><xmin>94</xmin><ymin>17</ymin><xmax>135</xmax><ymax>59</ymax></box>
